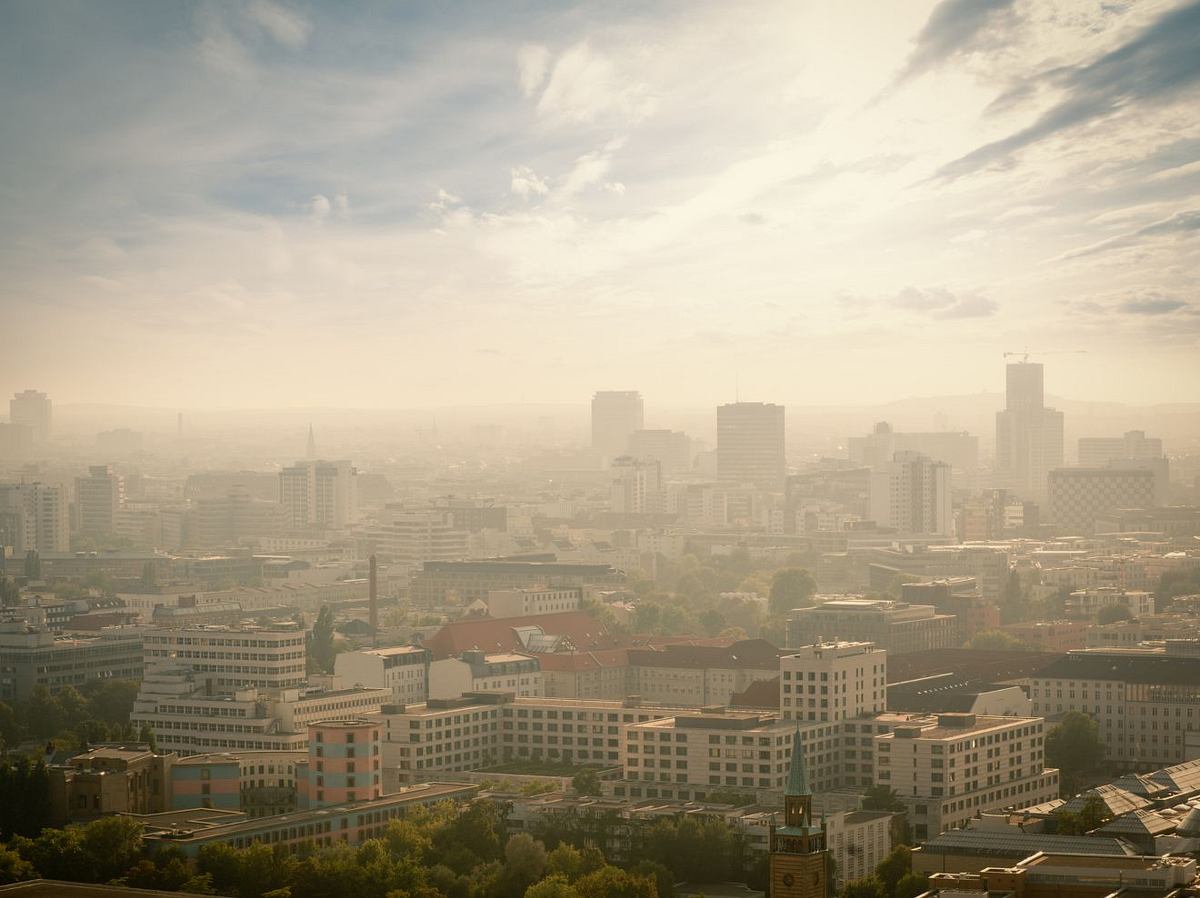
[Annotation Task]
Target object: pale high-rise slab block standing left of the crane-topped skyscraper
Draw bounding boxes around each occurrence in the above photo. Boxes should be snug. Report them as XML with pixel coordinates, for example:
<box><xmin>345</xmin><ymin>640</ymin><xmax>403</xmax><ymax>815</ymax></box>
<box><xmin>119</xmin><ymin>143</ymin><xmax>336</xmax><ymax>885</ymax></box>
<box><xmin>871</xmin><ymin>451</ymin><xmax>954</xmax><ymax>537</ymax></box>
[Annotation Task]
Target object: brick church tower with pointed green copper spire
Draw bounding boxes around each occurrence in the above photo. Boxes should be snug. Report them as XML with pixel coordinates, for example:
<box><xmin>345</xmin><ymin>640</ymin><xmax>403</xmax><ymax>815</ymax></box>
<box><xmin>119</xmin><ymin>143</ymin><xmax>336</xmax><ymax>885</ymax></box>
<box><xmin>770</xmin><ymin>729</ymin><xmax>829</xmax><ymax>898</ymax></box>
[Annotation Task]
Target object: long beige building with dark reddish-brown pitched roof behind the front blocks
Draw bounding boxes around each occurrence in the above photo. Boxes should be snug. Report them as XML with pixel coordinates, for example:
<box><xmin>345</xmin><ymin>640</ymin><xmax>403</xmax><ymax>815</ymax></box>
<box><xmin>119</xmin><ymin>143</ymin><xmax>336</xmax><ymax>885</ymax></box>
<box><xmin>628</xmin><ymin>639</ymin><xmax>780</xmax><ymax>707</ymax></box>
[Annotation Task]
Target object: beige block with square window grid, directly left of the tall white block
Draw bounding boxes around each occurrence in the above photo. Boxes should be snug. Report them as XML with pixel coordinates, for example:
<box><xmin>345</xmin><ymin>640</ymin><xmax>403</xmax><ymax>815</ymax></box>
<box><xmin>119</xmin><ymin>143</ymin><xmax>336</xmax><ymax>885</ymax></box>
<box><xmin>623</xmin><ymin>711</ymin><xmax>796</xmax><ymax>792</ymax></box>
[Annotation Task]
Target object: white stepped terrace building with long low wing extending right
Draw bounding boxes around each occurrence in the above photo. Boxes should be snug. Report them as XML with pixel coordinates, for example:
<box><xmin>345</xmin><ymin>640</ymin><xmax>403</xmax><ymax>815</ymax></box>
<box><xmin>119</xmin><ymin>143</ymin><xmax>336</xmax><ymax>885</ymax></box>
<box><xmin>130</xmin><ymin>663</ymin><xmax>389</xmax><ymax>755</ymax></box>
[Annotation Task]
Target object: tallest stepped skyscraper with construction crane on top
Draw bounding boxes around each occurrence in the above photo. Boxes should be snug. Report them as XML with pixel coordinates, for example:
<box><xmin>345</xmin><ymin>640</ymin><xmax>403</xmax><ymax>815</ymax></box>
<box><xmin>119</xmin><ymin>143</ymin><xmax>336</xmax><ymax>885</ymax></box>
<box><xmin>996</xmin><ymin>361</ymin><xmax>1063</xmax><ymax>501</ymax></box>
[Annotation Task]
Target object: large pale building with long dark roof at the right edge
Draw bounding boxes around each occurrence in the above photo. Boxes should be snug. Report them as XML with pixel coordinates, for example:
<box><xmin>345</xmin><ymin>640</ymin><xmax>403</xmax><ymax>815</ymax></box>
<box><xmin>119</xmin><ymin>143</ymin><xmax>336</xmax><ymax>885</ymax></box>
<box><xmin>1030</xmin><ymin>640</ymin><xmax>1200</xmax><ymax>770</ymax></box>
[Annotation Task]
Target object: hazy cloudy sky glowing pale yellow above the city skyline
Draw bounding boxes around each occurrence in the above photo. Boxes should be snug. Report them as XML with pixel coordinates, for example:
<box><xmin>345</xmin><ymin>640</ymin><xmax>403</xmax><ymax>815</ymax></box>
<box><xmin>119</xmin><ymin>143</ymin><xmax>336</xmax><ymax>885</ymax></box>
<box><xmin>0</xmin><ymin>0</ymin><xmax>1200</xmax><ymax>408</ymax></box>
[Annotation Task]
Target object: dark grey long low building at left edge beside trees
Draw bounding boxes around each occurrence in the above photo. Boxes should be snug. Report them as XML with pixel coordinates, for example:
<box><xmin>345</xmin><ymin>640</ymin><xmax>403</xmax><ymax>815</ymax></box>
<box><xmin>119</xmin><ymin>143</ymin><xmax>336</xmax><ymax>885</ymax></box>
<box><xmin>0</xmin><ymin>619</ymin><xmax>143</xmax><ymax>702</ymax></box>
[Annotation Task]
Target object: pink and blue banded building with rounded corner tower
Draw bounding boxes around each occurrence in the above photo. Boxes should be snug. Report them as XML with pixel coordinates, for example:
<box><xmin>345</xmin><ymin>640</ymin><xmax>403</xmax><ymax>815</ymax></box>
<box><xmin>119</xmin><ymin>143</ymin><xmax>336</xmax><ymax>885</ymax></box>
<box><xmin>300</xmin><ymin>718</ymin><xmax>383</xmax><ymax>808</ymax></box>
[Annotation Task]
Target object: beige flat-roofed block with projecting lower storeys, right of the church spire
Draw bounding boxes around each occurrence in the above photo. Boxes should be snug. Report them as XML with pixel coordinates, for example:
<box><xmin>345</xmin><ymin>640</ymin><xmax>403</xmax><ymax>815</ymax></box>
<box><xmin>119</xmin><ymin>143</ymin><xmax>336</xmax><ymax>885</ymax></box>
<box><xmin>875</xmin><ymin>714</ymin><xmax>1058</xmax><ymax>839</ymax></box>
